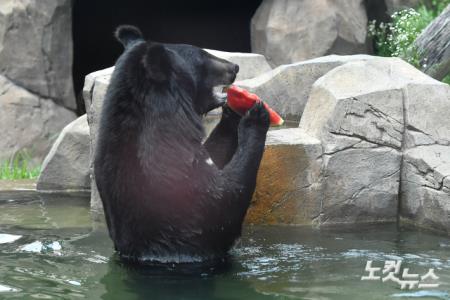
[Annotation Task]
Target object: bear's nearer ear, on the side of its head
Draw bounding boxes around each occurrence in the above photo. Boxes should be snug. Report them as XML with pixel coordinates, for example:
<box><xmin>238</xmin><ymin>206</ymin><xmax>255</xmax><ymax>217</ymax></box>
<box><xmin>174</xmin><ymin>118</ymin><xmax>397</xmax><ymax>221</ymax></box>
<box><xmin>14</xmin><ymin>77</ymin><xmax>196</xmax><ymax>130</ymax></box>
<box><xmin>143</xmin><ymin>43</ymin><xmax>172</xmax><ymax>82</ymax></box>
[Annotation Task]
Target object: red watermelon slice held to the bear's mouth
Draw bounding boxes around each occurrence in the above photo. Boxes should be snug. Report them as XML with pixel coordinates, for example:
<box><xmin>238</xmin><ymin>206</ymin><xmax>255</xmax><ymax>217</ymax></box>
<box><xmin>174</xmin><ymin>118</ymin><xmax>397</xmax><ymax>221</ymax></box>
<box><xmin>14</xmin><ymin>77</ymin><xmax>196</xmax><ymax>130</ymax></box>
<box><xmin>227</xmin><ymin>85</ymin><xmax>284</xmax><ymax>126</ymax></box>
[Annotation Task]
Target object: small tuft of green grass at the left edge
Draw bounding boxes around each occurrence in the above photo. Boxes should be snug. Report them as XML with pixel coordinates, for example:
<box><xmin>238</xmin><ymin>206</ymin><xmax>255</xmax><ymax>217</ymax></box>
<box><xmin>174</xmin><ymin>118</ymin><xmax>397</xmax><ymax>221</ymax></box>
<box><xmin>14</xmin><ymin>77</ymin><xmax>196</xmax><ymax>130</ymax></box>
<box><xmin>0</xmin><ymin>151</ymin><xmax>41</xmax><ymax>180</ymax></box>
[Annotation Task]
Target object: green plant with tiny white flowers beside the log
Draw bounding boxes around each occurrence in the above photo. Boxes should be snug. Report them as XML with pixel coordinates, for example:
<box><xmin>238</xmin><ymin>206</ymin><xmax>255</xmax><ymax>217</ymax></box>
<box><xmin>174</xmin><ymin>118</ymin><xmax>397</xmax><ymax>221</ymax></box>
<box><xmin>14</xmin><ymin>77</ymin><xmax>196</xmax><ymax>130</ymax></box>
<box><xmin>368</xmin><ymin>0</ymin><xmax>450</xmax><ymax>84</ymax></box>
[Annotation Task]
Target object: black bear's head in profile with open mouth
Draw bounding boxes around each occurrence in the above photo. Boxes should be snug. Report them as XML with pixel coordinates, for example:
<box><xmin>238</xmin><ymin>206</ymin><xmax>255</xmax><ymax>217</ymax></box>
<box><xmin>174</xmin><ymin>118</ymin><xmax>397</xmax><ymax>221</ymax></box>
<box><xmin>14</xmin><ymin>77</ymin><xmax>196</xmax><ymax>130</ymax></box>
<box><xmin>116</xmin><ymin>25</ymin><xmax>239</xmax><ymax>115</ymax></box>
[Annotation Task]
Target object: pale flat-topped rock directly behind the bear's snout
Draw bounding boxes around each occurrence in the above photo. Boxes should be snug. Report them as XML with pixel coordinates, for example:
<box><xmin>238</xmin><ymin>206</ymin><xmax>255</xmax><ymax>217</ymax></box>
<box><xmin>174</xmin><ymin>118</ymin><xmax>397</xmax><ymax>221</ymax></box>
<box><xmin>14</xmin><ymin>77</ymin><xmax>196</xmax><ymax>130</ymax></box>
<box><xmin>205</xmin><ymin>49</ymin><xmax>272</xmax><ymax>80</ymax></box>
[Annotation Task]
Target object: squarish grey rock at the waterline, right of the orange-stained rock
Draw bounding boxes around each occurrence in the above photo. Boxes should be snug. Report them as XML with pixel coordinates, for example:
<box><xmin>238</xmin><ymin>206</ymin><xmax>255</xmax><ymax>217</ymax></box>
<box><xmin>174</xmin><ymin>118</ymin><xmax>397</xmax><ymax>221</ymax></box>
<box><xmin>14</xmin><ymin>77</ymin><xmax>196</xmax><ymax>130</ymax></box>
<box><xmin>319</xmin><ymin>144</ymin><xmax>401</xmax><ymax>224</ymax></box>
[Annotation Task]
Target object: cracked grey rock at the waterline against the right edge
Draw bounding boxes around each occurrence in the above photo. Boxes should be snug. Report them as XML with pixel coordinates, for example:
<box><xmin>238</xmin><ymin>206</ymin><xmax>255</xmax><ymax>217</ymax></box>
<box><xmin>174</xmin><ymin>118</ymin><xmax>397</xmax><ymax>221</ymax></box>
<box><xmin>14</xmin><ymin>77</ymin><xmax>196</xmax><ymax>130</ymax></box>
<box><xmin>400</xmin><ymin>145</ymin><xmax>450</xmax><ymax>234</ymax></box>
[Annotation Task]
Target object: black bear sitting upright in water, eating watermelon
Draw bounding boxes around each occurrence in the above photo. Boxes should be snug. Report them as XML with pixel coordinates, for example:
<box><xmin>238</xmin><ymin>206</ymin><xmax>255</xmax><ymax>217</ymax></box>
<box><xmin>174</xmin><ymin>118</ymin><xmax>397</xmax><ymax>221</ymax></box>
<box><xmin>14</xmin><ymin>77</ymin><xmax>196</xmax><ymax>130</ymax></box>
<box><xmin>94</xmin><ymin>25</ymin><xmax>269</xmax><ymax>263</ymax></box>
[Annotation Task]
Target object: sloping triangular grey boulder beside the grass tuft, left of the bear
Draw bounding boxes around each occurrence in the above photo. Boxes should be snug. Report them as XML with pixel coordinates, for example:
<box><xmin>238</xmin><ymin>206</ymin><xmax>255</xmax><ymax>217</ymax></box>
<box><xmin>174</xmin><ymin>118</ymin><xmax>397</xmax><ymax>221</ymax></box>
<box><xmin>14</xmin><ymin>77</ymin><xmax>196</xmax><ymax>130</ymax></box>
<box><xmin>37</xmin><ymin>115</ymin><xmax>91</xmax><ymax>190</ymax></box>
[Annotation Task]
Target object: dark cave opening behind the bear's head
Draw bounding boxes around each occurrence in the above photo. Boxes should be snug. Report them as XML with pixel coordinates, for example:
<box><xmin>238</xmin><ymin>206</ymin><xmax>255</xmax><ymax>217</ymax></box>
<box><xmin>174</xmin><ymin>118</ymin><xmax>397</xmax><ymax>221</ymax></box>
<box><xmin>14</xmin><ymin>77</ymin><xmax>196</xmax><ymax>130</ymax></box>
<box><xmin>73</xmin><ymin>0</ymin><xmax>262</xmax><ymax>114</ymax></box>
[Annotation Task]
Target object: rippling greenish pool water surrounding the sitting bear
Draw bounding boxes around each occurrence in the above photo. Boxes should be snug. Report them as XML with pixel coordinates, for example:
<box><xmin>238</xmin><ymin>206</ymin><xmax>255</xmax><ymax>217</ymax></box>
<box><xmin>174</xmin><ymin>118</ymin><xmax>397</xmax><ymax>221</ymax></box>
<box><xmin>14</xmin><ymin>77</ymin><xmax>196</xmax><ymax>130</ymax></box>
<box><xmin>0</xmin><ymin>196</ymin><xmax>450</xmax><ymax>300</ymax></box>
